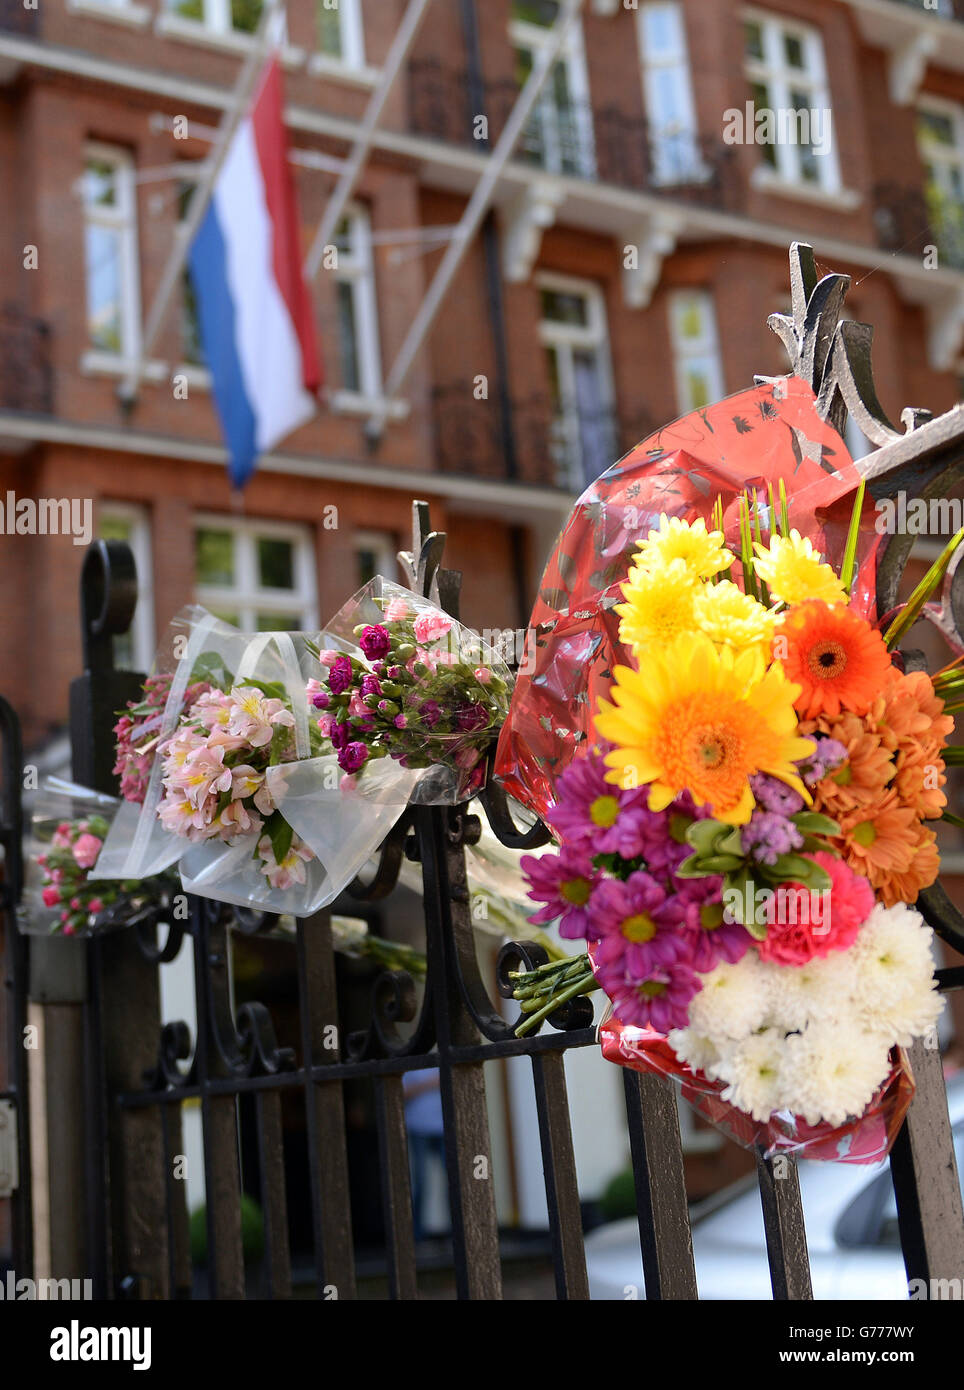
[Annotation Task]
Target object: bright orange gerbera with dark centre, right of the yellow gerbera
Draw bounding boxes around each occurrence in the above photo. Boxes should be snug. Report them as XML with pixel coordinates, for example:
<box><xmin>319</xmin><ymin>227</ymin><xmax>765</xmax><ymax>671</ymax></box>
<box><xmin>774</xmin><ymin>599</ymin><xmax>890</xmax><ymax>719</ymax></box>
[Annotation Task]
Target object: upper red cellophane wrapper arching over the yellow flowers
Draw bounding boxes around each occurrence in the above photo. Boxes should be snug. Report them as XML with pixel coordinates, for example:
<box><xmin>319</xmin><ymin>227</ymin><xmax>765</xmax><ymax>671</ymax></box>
<box><xmin>495</xmin><ymin>377</ymin><xmax>881</xmax><ymax>816</ymax></box>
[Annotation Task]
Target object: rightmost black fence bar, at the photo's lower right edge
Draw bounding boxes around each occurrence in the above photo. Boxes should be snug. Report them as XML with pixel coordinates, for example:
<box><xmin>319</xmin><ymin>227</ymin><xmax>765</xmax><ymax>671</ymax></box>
<box><xmin>890</xmin><ymin>1038</ymin><xmax>964</xmax><ymax>1293</ymax></box>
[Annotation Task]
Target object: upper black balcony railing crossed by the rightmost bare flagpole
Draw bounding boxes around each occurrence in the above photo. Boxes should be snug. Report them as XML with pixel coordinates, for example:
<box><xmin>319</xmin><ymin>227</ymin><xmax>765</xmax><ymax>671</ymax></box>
<box><xmin>408</xmin><ymin>58</ymin><xmax>740</xmax><ymax>209</ymax></box>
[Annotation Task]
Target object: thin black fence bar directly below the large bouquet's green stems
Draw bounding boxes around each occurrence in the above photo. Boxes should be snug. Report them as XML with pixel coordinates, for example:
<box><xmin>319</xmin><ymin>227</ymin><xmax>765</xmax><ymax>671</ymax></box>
<box><xmin>532</xmin><ymin>1052</ymin><xmax>589</xmax><ymax>1298</ymax></box>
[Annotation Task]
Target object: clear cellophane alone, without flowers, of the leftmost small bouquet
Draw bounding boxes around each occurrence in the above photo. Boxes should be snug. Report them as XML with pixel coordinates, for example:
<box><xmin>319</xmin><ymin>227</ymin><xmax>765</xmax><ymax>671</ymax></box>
<box><xmin>17</xmin><ymin>777</ymin><xmax>163</xmax><ymax>937</ymax></box>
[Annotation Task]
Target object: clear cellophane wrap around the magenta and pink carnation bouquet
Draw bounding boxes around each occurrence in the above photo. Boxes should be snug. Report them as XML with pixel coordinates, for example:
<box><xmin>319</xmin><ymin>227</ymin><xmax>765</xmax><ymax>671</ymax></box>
<box><xmin>324</xmin><ymin>574</ymin><xmax>513</xmax><ymax>806</ymax></box>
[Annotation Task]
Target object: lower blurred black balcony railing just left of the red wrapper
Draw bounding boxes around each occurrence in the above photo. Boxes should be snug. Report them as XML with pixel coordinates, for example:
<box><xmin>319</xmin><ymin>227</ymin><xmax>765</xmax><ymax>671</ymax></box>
<box><xmin>432</xmin><ymin>381</ymin><xmax>656</xmax><ymax>492</ymax></box>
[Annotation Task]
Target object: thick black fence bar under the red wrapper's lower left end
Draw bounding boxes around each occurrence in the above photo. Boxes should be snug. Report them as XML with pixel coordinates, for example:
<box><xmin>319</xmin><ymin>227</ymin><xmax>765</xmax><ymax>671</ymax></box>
<box><xmin>622</xmin><ymin>1069</ymin><xmax>699</xmax><ymax>1300</ymax></box>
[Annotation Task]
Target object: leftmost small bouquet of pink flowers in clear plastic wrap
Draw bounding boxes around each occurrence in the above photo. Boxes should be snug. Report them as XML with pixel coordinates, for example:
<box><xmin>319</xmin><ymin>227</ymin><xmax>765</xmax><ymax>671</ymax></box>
<box><xmin>17</xmin><ymin>777</ymin><xmax>181</xmax><ymax>935</ymax></box>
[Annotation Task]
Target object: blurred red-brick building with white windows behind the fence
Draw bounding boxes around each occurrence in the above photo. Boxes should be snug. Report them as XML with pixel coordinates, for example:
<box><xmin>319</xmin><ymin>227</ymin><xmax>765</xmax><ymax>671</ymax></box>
<box><xmin>0</xmin><ymin>0</ymin><xmax>964</xmax><ymax>1273</ymax></box>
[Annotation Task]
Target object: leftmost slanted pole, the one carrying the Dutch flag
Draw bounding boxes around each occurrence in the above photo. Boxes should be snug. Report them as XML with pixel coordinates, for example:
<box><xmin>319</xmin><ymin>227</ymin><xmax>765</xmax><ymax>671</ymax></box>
<box><xmin>117</xmin><ymin>0</ymin><xmax>282</xmax><ymax>410</ymax></box>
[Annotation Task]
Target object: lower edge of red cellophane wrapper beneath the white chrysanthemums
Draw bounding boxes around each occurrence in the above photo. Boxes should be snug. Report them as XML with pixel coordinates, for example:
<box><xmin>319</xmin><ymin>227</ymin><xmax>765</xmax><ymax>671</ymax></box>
<box><xmin>599</xmin><ymin>1017</ymin><xmax>915</xmax><ymax>1163</ymax></box>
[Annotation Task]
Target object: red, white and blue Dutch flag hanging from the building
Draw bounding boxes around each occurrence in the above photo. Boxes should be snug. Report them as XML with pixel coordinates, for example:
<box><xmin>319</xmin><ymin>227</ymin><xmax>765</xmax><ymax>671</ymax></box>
<box><xmin>188</xmin><ymin>57</ymin><xmax>322</xmax><ymax>488</ymax></box>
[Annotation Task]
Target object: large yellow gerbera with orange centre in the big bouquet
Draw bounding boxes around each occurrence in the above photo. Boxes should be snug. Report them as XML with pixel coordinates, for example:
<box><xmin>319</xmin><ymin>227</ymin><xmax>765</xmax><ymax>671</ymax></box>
<box><xmin>596</xmin><ymin>632</ymin><xmax>814</xmax><ymax>826</ymax></box>
